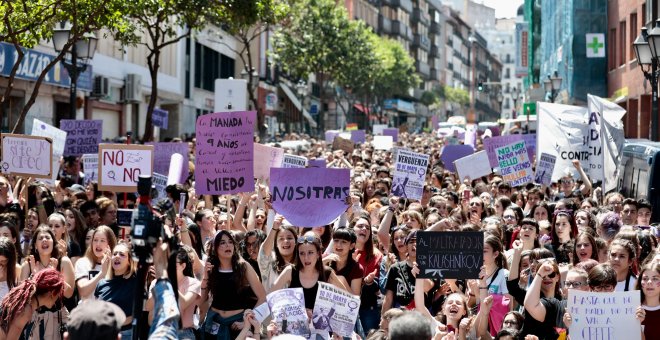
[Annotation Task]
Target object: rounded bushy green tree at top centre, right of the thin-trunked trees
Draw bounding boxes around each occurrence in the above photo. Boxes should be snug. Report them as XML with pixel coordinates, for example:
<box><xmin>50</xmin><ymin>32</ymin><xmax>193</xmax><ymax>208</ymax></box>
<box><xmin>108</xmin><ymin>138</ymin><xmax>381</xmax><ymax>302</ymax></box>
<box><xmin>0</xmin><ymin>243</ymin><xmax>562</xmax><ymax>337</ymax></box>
<box><xmin>273</xmin><ymin>0</ymin><xmax>354</xmax><ymax>131</ymax></box>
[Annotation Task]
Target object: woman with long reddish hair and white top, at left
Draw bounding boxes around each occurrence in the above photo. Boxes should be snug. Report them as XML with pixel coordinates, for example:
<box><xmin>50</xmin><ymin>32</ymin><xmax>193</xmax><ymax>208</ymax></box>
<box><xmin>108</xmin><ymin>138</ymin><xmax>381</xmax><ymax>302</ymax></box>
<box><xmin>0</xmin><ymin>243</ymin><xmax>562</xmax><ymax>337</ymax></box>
<box><xmin>76</xmin><ymin>225</ymin><xmax>117</xmax><ymax>300</ymax></box>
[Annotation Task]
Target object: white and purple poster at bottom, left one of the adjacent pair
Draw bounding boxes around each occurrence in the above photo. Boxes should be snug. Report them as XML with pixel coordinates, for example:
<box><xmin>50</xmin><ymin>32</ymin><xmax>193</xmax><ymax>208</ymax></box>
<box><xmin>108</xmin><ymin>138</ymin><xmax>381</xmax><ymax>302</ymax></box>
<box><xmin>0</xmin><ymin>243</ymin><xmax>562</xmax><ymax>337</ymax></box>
<box><xmin>266</xmin><ymin>288</ymin><xmax>311</xmax><ymax>338</ymax></box>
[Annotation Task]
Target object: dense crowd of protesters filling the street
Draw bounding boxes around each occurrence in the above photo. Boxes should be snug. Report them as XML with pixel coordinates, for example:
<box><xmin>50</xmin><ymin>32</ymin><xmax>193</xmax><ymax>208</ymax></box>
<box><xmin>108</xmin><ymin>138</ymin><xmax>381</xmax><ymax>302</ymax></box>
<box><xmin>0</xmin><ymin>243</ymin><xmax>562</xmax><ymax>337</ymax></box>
<box><xmin>0</xmin><ymin>133</ymin><xmax>660</xmax><ymax>340</ymax></box>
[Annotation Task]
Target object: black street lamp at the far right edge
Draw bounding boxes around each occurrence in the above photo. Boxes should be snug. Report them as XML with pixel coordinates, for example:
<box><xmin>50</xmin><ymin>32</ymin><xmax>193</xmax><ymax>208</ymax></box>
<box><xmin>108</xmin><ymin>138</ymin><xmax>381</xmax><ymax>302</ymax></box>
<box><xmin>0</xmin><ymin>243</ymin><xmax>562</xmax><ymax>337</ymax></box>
<box><xmin>633</xmin><ymin>24</ymin><xmax>660</xmax><ymax>141</ymax></box>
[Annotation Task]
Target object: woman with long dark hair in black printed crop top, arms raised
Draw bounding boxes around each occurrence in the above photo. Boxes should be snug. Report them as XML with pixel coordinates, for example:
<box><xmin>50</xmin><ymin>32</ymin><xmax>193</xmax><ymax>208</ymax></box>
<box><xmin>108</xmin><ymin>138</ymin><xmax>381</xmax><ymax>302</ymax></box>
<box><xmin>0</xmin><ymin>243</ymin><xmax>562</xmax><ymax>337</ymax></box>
<box><xmin>202</xmin><ymin>230</ymin><xmax>266</xmax><ymax>340</ymax></box>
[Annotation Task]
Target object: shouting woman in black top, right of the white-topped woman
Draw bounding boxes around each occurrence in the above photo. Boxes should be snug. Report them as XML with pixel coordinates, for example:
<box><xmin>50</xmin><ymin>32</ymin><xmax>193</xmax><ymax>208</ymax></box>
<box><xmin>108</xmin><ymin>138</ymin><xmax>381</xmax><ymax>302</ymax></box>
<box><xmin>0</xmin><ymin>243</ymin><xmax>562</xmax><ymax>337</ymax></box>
<box><xmin>94</xmin><ymin>243</ymin><xmax>137</xmax><ymax>339</ymax></box>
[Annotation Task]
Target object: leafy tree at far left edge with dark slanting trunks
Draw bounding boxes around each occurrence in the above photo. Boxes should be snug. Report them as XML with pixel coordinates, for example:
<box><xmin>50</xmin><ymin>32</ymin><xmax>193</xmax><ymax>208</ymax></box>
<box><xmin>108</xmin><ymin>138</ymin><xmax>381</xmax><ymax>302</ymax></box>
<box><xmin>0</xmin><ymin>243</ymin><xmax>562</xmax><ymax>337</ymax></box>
<box><xmin>0</xmin><ymin>0</ymin><xmax>129</xmax><ymax>133</ymax></box>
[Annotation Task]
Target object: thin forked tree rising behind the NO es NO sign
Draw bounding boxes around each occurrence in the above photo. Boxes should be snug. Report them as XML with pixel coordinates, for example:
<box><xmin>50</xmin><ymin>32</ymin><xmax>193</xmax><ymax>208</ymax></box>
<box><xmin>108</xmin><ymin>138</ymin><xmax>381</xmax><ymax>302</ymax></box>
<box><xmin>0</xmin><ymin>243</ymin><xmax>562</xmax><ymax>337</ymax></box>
<box><xmin>114</xmin><ymin>0</ymin><xmax>214</xmax><ymax>142</ymax></box>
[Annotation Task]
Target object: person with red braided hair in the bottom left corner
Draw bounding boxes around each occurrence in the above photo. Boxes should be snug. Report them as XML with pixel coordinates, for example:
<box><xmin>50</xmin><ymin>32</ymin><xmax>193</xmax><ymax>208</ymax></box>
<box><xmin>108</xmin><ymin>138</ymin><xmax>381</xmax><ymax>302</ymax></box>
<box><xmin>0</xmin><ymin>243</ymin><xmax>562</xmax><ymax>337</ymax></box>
<box><xmin>0</xmin><ymin>268</ymin><xmax>65</xmax><ymax>340</ymax></box>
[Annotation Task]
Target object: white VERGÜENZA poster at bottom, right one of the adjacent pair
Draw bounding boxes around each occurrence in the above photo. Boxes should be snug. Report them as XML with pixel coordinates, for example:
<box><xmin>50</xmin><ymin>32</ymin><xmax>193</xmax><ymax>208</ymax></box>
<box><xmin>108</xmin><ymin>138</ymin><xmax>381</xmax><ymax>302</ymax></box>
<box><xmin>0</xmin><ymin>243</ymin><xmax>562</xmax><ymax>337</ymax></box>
<box><xmin>312</xmin><ymin>282</ymin><xmax>360</xmax><ymax>337</ymax></box>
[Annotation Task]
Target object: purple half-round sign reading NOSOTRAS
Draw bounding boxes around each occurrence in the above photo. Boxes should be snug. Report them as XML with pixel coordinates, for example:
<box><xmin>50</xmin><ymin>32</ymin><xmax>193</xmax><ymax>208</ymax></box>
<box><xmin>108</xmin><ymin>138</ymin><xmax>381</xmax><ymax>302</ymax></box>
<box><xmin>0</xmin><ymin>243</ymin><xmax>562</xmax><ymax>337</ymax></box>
<box><xmin>270</xmin><ymin>168</ymin><xmax>350</xmax><ymax>227</ymax></box>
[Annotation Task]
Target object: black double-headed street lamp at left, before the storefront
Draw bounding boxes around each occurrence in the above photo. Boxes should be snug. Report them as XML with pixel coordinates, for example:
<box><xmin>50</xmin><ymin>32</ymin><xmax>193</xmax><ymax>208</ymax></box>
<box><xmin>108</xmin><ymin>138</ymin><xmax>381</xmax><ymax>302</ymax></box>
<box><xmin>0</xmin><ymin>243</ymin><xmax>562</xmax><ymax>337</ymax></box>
<box><xmin>53</xmin><ymin>21</ymin><xmax>98</xmax><ymax>119</ymax></box>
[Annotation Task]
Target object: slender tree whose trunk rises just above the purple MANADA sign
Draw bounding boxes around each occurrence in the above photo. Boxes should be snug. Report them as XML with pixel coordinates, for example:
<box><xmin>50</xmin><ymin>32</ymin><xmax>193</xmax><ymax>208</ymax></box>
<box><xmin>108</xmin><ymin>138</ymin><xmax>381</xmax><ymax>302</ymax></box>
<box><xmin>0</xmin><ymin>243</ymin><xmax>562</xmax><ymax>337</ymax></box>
<box><xmin>208</xmin><ymin>0</ymin><xmax>290</xmax><ymax>136</ymax></box>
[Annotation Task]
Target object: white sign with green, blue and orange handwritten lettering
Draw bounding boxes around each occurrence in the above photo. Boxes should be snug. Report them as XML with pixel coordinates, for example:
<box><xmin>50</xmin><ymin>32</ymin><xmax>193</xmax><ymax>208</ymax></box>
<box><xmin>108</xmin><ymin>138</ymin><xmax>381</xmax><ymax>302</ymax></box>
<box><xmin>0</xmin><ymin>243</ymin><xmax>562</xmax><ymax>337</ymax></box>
<box><xmin>495</xmin><ymin>141</ymin><xmax>534</xmax><ymax>187</ymax></box>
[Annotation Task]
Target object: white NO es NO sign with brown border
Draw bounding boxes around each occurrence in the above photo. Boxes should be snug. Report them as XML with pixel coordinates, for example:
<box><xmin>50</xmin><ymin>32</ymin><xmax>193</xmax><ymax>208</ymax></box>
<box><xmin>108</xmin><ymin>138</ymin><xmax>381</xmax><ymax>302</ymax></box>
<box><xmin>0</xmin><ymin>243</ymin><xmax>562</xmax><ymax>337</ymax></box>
<box><xmin>98</xmin><ymin>144</ymin><xmax>154</xmax><ymax>192</ymax></box>
